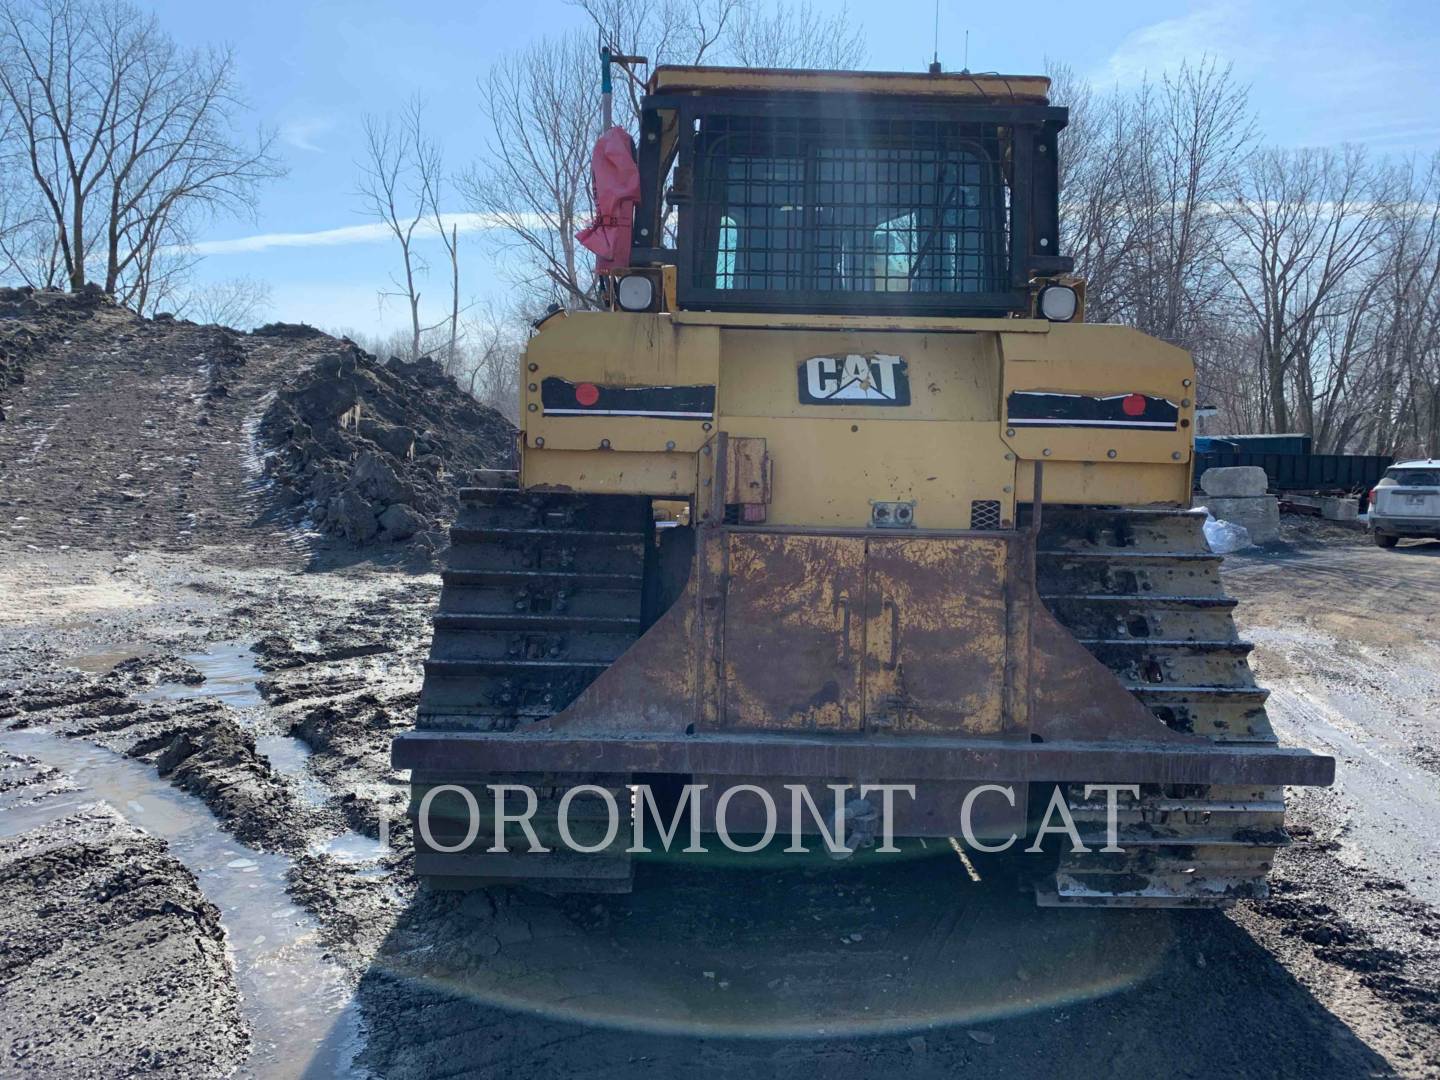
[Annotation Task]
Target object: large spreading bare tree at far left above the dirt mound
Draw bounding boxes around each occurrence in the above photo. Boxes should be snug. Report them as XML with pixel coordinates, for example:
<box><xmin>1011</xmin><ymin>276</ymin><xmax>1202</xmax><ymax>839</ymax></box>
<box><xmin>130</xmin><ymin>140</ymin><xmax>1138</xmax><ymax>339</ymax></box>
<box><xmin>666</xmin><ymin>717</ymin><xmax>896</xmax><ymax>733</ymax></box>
<box><xmin>0</xmin><ymin>0</ymin><xmax>281</xmax><ymax>301</ymax></box>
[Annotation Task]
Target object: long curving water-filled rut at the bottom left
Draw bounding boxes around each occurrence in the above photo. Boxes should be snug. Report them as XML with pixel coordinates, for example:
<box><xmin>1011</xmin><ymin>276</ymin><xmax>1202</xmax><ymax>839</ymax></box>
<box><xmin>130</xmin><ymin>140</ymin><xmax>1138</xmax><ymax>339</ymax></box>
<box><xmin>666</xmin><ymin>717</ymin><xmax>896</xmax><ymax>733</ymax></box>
<box><xmin>0</xmin><ymin>729</ymin><xmax>360</xmax><ymax>1080</ymax></box>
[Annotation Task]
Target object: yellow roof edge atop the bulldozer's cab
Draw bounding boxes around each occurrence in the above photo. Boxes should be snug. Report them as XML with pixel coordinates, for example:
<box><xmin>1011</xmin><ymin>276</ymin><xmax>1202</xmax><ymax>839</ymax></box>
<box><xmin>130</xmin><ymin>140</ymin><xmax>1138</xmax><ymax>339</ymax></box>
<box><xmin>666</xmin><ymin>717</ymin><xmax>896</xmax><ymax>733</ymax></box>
<box><xmin>648</xmin><ymin>65</ymin><xmax>1050</xmax><ymax>105</ymax></box>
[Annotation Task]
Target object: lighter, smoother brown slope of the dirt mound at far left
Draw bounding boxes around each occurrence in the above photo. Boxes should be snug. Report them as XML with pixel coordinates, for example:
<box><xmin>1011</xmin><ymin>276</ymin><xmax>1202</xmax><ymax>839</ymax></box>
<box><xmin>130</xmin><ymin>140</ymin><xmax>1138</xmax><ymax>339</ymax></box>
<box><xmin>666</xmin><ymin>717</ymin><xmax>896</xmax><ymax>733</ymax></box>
<box><xmin>0</xmin><ymin>289</ymin><xmax>347</xmax><ymax>559</ymax></box>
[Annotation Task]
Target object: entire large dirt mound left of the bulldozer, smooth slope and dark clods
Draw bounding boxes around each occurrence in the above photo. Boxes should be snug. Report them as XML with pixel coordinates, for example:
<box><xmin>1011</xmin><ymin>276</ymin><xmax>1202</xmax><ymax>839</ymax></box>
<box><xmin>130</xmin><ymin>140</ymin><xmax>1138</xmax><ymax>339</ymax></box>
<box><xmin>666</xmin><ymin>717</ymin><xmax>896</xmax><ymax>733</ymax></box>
<box><xmin>0</xmin><ymin>289</ymin><xmax>514</xmax><ymax>557</ymax></box>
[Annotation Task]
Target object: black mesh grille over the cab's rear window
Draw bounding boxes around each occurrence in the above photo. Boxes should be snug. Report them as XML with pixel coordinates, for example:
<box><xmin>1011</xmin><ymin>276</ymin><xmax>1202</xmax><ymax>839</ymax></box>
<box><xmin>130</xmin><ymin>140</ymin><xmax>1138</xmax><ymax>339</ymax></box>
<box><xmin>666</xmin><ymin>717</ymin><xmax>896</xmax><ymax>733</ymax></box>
<box><xmin>694</xmin><ymin>115</ymin><xmax>1009</xmax><ymax>294</ymax></box>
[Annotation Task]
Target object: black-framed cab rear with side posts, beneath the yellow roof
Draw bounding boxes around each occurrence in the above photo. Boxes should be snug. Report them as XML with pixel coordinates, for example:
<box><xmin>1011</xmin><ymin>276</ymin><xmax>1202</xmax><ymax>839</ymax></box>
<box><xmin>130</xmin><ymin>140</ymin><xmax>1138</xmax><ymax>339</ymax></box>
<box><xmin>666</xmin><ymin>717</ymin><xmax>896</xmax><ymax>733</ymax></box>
<box><xmin>653</xmin><ymin>94</ymin><xmax>1070</xmax><ymax>317</ymax></box>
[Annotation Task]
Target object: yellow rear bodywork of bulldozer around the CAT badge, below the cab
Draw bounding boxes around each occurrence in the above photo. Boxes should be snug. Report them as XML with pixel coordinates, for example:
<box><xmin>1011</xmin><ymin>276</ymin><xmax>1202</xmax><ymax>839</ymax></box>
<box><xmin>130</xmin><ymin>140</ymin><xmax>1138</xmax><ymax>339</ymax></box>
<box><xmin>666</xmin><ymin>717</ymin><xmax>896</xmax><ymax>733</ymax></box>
<box><xmin>521</xmin><ymin>311</ymin><xmax>1194</xmax><ymax>530</ymax></box>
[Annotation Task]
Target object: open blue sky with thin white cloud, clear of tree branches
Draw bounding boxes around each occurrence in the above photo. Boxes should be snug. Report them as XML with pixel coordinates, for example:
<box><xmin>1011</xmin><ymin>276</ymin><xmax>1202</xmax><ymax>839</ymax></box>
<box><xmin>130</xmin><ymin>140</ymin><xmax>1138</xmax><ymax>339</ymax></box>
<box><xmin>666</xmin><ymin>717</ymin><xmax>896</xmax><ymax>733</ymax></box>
<box><xmin>149</xmin><ymin>0</ymin><xmax>1440</xmax><ymax>333</ymax></box>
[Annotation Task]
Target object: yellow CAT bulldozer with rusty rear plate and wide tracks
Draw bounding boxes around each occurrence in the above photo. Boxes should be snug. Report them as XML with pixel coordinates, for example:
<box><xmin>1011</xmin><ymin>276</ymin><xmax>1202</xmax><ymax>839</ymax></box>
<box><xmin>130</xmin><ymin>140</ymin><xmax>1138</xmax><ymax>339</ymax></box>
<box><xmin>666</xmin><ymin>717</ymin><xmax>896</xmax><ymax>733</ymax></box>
<box><xmin>393</xmin><ymin>59</ymin><xmax>1335</xmax><ymax>907</ymax></box>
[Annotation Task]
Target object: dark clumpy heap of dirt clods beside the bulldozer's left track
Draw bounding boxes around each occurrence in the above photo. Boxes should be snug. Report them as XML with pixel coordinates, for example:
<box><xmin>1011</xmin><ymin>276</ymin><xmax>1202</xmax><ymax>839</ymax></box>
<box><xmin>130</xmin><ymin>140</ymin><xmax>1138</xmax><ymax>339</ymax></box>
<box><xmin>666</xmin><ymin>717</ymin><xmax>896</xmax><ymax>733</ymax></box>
<box><xmin>256</xmin><ymin>344</ymin><xmax>514</xmax><ymax>552</ymax></box>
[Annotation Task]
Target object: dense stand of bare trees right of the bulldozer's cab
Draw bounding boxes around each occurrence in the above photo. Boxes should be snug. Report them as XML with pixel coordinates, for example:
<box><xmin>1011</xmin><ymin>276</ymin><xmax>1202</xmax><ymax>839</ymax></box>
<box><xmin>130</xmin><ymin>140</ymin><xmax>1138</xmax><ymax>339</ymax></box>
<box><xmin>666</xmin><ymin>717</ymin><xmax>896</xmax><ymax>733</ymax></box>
<box><xmin>1051</xmin><ymin>60</ymin><xmax>1440</xmax><ymax>455</ymax></box>
